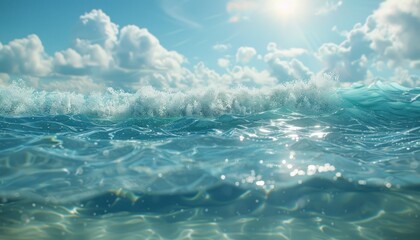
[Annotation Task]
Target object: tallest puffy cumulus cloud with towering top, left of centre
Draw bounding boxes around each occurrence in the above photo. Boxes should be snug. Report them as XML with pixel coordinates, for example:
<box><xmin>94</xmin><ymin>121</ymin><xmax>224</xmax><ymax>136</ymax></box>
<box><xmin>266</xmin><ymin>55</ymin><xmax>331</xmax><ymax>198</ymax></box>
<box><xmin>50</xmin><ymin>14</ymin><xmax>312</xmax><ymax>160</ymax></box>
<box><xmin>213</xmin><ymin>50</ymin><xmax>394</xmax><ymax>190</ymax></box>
<box><xmin>76</xmin><ymin>10</ymin><xmax>184</xmax><ymax>82</ymax></box>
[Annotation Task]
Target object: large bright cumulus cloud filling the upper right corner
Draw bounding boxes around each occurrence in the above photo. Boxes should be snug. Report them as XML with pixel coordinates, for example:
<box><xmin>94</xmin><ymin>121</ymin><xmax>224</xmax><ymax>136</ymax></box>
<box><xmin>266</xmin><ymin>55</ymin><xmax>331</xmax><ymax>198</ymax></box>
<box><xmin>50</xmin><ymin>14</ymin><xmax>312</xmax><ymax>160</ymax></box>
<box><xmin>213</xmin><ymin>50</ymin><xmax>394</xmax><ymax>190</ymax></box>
<box><xmin>317</xmin><ymin>0</ymin><xmax>420</xmax><ymax>82</ymax></box>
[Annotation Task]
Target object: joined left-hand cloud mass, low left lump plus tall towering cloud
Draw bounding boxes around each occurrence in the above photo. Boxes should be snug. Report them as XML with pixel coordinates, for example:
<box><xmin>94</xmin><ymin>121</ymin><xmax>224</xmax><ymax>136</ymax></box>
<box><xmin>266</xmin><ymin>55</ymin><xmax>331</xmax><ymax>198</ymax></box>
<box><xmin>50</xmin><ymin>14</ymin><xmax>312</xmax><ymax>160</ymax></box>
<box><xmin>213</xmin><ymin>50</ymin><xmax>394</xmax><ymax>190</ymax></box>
<box><xmin>0</xmin><ymin>10</ymin><xmax>191</xmax><ymax>89</ymax></box>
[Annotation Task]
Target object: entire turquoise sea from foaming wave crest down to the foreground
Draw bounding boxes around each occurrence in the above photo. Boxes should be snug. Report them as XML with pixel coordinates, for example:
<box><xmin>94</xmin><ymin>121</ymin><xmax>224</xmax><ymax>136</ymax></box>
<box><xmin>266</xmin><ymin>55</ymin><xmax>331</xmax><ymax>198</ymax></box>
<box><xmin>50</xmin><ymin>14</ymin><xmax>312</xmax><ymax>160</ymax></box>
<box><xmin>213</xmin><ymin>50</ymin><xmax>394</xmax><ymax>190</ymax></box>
<box><xmin>0</xmin><ymin>82</ymin><xmax>420</xmax><ymax>239</ymax></box>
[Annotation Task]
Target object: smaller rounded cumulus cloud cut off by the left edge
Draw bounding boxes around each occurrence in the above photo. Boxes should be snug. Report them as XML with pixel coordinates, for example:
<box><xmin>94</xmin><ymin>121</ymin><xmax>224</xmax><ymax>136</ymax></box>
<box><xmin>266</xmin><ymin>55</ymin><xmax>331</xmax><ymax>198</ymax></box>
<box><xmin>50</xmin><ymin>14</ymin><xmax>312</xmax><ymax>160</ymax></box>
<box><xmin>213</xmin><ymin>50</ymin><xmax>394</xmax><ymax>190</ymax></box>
<box><xmin>0</xmin><ymin>34</ymin><xmax>52</xmax><ymax>76</ymax></box>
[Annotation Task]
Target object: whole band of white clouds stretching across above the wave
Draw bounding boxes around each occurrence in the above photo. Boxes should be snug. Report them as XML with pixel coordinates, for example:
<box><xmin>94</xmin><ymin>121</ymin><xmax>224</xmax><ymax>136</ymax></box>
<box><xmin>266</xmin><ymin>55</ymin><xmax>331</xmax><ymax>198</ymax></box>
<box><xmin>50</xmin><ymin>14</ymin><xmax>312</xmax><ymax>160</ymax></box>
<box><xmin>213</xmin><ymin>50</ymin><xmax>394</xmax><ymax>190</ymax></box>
<box><xmin>0</xmin><ymin>0</ymin><xmax>420</xmax><ymax>91</ymax></box>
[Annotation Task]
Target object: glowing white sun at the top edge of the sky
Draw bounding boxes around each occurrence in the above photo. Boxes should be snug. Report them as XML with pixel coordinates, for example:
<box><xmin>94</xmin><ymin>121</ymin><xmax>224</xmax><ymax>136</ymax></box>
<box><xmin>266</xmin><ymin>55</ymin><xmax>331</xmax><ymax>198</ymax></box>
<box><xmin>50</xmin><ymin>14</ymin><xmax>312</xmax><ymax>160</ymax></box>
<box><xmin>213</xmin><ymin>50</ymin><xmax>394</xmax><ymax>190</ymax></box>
<box><xmin>266</xmin><ymin>0</ymin><xmax>300</xmax><ymax>18</ymax></box>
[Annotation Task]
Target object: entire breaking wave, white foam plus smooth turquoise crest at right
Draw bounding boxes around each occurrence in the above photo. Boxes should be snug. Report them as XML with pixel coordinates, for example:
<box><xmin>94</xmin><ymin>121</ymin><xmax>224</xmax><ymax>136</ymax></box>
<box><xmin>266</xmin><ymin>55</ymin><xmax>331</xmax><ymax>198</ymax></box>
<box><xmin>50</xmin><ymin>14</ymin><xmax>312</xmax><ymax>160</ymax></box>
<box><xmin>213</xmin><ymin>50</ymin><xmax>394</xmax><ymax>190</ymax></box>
<box><xmin>0</xmin><ymin>81</ymin><xmax>420</xmax><ymax>118</ymax></box>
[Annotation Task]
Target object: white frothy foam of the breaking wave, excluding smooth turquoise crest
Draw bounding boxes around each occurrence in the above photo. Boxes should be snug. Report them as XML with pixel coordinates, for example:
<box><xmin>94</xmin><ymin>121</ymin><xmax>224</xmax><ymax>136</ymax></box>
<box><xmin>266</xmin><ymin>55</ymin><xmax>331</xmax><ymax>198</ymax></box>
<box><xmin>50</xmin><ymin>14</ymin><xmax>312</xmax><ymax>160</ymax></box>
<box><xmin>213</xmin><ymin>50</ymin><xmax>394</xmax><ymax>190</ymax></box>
<box><xmin>0</xmin><ymin>81</ymin><xmax>337</xmax><ymax>117</ymax></box>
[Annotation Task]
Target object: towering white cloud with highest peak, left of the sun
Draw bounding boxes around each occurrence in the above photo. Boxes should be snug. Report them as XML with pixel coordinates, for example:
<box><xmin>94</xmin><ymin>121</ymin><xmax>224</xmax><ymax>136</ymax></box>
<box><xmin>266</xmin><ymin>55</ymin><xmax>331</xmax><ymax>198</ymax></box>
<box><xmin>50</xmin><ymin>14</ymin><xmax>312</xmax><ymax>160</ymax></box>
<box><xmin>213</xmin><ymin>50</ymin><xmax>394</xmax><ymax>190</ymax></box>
<box><xmin>73</xmin><ymin>10</ymin><xmax>187</xmax><ymax>89</ymax></box>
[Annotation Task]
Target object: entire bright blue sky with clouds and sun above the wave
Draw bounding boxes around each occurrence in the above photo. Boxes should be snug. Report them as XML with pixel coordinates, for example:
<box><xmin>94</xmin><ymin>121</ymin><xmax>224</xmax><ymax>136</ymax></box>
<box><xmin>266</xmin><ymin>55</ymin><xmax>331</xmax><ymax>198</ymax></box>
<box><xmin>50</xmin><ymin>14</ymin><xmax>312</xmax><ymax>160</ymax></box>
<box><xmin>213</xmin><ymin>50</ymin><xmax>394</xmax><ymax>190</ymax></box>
<box><xmin>0</xmin><ymin>0</ymin><xmax>420</xmax><ymax>91</ymax></box>
